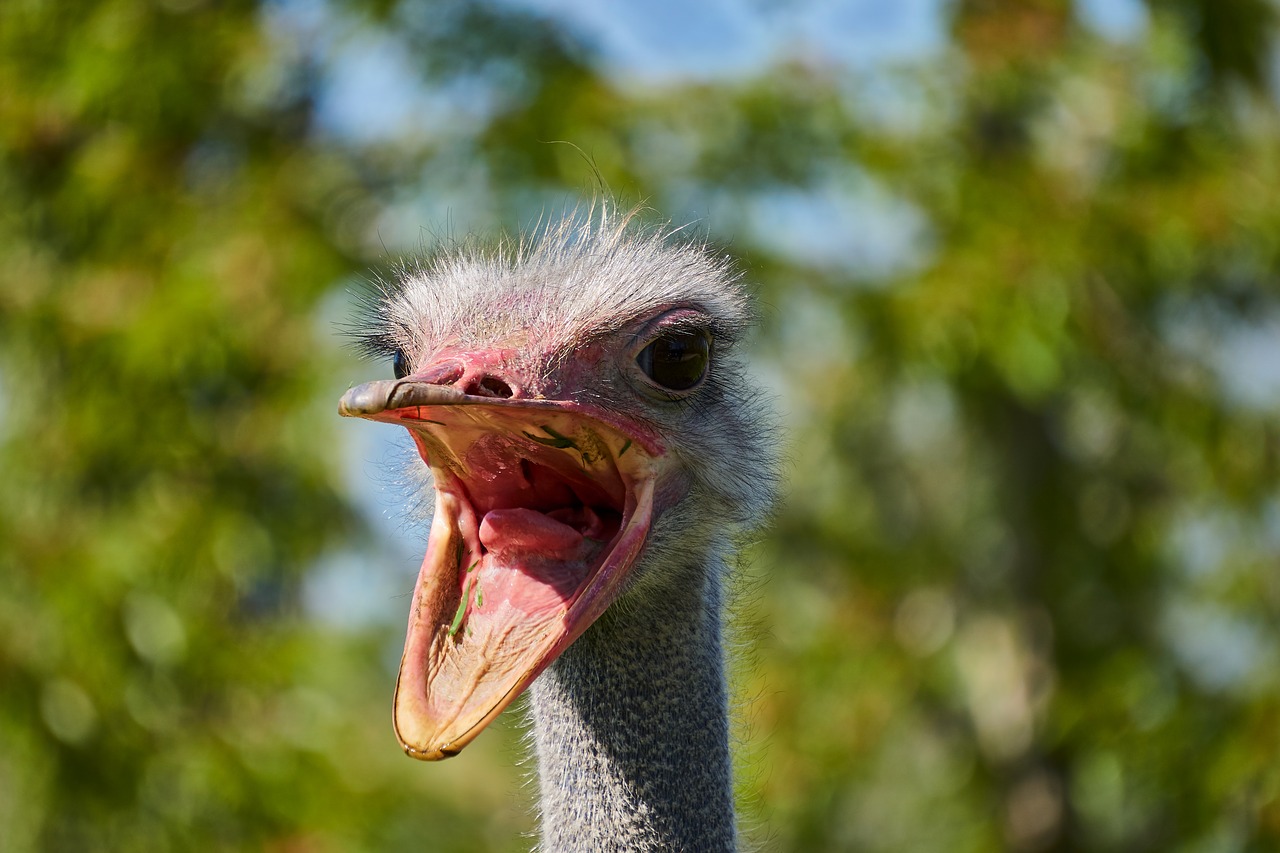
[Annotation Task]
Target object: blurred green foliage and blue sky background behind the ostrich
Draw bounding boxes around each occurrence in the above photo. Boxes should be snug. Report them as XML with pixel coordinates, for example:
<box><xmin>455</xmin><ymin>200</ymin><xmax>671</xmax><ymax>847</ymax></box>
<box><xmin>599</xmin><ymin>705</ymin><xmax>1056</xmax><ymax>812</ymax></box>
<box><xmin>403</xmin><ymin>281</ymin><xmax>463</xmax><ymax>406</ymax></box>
<box><xmin>0</xmin><ymin>0</ymin><xmax>1280</xmax><ymax>853</ymax></box>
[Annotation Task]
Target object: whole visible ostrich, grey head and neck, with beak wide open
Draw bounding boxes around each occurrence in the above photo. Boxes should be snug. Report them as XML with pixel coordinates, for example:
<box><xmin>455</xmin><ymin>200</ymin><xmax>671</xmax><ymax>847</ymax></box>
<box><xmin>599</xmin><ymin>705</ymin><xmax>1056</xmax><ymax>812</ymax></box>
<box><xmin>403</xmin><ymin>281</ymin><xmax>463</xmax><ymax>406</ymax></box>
<box><xmin>339</xmin><ymin>209</ymin><xmax>773</xmax><ymax>850</ymax></box>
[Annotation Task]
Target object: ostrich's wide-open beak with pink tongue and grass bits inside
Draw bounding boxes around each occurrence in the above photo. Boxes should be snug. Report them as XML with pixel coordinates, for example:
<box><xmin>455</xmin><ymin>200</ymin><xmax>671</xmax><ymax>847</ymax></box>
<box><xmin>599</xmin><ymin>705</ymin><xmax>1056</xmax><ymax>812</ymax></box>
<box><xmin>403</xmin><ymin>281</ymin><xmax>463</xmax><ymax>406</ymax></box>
<box><xmin>338</xmin><ymin>378</ymin><xmax>662</xmax><ymax>760</ymax></box>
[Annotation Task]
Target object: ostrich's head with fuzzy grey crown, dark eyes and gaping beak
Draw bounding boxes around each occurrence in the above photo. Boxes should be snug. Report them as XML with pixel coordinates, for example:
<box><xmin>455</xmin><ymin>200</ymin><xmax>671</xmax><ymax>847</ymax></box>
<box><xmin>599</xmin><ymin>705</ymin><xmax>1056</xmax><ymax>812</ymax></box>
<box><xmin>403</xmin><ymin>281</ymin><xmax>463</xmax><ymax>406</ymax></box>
<box><xmin>339</xmin><ymin>213</ymin><xmax>772</xmax><ymax>760</ymax></box>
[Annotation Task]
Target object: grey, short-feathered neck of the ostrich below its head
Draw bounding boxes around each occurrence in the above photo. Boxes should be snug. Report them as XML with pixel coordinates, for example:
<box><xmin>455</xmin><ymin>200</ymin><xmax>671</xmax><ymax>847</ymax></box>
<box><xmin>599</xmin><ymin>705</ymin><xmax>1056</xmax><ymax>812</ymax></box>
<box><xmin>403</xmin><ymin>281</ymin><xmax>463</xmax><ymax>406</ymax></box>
<box><xmin>532</xmin><ymin>561</ymin><xmax>735</xmax><ymax>853</ymax></box>
